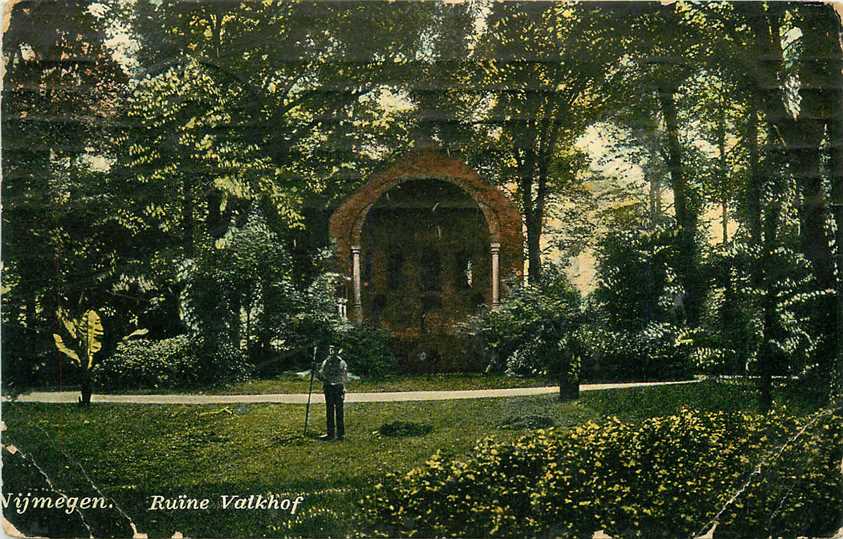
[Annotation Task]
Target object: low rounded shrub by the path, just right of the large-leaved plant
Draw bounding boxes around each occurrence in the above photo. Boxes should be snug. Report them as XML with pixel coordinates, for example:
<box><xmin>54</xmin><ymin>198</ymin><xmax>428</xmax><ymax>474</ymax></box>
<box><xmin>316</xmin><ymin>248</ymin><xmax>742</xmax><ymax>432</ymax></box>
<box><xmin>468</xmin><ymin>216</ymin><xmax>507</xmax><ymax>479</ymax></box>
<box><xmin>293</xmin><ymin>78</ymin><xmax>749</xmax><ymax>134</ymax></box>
<box><xmin>92</xmin><ymin>335</ymin><xmax>200</xmax><ymax>390</ymax></box>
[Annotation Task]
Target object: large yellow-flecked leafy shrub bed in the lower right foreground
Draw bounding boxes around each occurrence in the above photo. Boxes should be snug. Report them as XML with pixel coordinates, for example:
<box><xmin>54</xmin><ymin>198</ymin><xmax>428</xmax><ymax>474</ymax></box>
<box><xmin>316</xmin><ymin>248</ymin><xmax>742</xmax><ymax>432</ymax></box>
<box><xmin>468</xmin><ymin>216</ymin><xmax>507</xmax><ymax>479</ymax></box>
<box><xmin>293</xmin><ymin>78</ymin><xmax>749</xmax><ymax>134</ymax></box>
<box><xmin>360</xmin><ymin>409</ymin><xmax>843</xmax><ymax>537</ymax></box>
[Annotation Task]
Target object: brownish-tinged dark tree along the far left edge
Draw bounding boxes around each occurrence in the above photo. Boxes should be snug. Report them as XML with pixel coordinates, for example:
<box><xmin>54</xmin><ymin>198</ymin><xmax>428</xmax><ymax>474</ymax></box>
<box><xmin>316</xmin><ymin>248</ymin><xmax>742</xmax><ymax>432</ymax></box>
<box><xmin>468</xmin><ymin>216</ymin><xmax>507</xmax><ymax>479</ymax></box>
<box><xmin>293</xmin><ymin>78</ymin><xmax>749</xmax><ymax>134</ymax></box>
<box><xmin>2</xmin><ymin>1</ymin><xmax>125</xmax><ymax>383</ymax></box>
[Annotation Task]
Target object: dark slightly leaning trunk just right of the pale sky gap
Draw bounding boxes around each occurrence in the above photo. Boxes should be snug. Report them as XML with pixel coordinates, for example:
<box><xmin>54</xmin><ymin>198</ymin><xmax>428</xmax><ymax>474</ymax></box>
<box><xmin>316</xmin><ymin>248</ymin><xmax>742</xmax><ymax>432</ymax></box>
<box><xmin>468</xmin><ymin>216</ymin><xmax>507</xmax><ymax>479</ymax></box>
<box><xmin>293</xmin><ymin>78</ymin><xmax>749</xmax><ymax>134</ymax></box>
<box><xmin>658</xmin><ymin>88</ymin><xmax>703</xmax><ymax>327</ymax></box>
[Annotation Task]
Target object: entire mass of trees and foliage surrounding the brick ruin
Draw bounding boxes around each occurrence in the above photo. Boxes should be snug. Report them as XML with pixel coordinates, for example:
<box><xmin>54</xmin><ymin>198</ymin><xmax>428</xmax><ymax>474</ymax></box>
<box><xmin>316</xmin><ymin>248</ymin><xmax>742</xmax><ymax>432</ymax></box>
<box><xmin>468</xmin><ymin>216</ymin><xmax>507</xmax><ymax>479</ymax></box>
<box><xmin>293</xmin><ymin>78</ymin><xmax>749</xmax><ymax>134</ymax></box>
<box><xmin>2</xmin><ymin>0</ymin><xmax>843</xmax><ymax>404</ymax></box>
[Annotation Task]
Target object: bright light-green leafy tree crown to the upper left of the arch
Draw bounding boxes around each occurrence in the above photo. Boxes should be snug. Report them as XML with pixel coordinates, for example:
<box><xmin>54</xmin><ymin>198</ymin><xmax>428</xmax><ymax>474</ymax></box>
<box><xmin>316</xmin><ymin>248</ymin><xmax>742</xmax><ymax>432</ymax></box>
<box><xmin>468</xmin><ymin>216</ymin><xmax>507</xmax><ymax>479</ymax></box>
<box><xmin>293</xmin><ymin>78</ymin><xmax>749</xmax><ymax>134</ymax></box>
<box><xmin>121</xmin><ymin>58</ymin><xmax>302</xmax><ymax>232</ymax></box>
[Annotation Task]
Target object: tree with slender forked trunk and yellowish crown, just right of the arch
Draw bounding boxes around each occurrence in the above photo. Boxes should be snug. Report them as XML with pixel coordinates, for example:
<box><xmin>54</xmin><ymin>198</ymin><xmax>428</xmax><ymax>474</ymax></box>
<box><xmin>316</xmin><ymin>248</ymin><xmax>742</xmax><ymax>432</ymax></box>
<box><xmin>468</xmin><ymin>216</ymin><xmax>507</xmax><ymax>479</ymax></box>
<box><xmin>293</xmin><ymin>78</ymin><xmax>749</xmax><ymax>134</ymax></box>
<box><xmin>475</xmin><ymin>2</ymin><xmax>621</xmax><ymax>280</ymax></box>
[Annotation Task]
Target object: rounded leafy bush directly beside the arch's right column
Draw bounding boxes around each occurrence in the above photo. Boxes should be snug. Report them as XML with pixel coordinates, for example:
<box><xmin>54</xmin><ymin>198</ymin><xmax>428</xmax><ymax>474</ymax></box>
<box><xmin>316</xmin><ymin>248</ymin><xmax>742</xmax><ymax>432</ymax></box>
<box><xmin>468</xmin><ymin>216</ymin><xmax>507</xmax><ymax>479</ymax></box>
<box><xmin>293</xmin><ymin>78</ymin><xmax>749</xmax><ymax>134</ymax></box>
<box><xmin>463</xmin><ymin>266</ymin><xmax>581</xmax><ymax>375</ymax></box>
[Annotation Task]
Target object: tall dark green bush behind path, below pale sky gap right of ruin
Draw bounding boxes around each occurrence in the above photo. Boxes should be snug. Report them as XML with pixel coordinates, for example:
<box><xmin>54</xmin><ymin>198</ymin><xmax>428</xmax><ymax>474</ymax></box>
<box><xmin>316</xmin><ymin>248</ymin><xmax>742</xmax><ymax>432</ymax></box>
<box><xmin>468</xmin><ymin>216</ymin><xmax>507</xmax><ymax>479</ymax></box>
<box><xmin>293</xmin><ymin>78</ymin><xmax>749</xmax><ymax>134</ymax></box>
<box><xmin>580</xmin><ymin>213</ymin><xmax>704</xmax><ymax>380</ymax></box>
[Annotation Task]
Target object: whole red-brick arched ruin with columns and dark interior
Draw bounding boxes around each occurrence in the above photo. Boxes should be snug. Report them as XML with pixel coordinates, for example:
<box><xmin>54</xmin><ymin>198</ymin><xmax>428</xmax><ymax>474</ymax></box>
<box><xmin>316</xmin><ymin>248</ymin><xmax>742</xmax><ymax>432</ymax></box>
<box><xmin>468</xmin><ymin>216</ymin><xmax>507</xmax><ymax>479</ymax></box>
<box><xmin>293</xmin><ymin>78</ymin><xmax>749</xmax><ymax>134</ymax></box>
<box><xmin>330</xmin><ymin>150</ymin><xmax>523</xmax><ymax>368</ymax></box>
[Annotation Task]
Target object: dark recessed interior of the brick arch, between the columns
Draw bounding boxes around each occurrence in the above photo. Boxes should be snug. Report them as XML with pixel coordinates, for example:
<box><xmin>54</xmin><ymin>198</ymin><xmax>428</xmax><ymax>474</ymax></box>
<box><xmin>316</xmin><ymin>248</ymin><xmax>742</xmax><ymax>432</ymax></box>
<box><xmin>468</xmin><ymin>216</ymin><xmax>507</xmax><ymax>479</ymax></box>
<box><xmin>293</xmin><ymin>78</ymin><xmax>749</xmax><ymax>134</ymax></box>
<box><xmin>359</xmin><ymin>178</ymin><xmax>492</xmax><ymax>337</ymax></box>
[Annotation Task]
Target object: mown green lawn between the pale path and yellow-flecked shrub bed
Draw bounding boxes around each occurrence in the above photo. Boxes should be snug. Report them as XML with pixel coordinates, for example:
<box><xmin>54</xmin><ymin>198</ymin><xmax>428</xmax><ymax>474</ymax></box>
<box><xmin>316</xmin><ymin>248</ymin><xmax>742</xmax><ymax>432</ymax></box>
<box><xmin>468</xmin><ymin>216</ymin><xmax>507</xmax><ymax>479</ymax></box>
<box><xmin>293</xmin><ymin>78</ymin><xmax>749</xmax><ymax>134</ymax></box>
<box><xmin>2</xmin><ymin>381</ymin><xmax>817</xmax><ymax>537</ymax></box>
